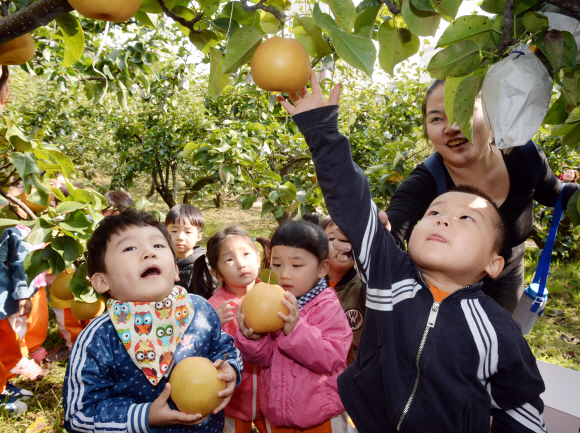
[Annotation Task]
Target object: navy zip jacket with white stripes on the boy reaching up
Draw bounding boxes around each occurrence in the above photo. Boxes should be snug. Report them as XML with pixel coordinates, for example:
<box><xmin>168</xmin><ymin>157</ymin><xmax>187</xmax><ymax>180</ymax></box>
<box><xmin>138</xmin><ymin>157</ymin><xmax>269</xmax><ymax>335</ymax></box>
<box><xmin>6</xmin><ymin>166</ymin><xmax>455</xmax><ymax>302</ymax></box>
<box><xmin>294</xmin><ymin>106</ymin><xmax>546</xmax><ymax>433</ymax></box>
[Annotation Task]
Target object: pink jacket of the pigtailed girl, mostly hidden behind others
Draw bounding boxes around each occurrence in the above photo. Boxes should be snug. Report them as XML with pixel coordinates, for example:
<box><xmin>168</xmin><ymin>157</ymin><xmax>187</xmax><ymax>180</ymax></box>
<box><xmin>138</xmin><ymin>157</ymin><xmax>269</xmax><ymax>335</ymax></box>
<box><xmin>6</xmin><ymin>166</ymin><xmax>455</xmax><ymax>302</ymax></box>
<box><xmin>209</xmin><ymin>286</ymin><xmax>264</xmax><ymax>421</ymax></box>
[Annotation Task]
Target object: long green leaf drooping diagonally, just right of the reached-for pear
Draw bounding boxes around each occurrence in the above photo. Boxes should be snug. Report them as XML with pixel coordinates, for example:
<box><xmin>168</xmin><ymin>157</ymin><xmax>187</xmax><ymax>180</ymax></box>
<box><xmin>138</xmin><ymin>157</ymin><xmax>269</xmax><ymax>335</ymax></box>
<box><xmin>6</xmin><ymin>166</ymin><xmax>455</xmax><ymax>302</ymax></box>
<box><xmin>312</xmin><ymin>3</ymin><xmax>377</xmax><ymax>77</ymax></box>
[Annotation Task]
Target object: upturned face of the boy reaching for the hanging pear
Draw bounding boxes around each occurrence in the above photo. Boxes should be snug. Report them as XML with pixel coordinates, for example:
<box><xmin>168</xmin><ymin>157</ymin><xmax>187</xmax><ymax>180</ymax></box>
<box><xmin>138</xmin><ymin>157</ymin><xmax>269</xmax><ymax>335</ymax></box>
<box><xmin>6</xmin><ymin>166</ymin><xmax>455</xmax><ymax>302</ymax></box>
<box><xmin>409</xmin><ymin>192</ymin><xmax>503</xmax><ymax>286</ymax></box>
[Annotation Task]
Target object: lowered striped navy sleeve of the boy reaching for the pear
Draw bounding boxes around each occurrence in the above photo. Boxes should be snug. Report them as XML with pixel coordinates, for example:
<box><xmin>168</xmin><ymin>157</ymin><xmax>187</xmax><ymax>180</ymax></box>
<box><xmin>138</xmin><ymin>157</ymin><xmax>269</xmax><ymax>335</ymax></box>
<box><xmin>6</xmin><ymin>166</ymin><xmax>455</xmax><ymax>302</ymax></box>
<box><xmin>461</xmin><ymin>299</ymin><xmax>546</xmax><ymax>433</ymax></box>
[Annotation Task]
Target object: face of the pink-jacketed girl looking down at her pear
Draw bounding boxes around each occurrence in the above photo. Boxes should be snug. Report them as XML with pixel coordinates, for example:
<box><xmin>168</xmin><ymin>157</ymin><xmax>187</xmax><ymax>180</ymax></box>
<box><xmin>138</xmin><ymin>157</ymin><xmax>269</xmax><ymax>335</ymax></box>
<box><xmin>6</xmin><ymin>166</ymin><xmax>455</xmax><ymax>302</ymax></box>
<box><xmin>272</xmin><ymin>245</ymin><xmax>328</xmax><ymax>298</ymax></box>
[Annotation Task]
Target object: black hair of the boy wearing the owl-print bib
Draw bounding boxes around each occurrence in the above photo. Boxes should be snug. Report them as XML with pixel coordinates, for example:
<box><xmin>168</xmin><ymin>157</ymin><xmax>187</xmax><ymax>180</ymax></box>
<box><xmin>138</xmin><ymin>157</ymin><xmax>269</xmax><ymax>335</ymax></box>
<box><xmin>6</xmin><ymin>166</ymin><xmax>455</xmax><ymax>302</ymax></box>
<box><xmin>87</xmin><ymin>208</ymin><xmax>177</xmax><ymax>278</ymax></box>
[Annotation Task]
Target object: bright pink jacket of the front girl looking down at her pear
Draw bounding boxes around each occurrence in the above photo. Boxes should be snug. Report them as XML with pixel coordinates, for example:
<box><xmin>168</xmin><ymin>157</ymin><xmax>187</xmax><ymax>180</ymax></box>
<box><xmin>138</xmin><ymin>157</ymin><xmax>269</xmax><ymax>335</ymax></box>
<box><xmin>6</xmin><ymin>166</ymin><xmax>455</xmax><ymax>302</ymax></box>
<box><xmin>236</xmin><ymin>288</ymin><xmax>352</xmax><ymax>428</ymax></box>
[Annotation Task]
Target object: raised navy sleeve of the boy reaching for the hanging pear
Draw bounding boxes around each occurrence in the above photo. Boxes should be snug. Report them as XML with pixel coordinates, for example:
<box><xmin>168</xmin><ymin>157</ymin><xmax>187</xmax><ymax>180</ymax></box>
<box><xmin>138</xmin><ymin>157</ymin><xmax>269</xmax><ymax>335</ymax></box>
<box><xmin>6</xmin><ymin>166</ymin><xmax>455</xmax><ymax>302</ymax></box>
<box><xmin>294</xmin><ymin>106</ymin><xmax>416</xmax><ymax>311</ymax></box>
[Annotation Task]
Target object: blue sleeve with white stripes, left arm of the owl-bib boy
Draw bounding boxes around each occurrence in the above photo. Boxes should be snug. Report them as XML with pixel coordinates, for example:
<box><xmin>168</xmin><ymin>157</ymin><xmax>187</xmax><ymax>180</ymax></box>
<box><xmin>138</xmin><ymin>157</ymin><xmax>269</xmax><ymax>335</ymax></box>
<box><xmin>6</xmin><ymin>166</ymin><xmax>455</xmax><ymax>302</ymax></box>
<box><xmin>63</xmin><ymin>314</ymin><xmax>151</xmax><ymax>433</ymax></box>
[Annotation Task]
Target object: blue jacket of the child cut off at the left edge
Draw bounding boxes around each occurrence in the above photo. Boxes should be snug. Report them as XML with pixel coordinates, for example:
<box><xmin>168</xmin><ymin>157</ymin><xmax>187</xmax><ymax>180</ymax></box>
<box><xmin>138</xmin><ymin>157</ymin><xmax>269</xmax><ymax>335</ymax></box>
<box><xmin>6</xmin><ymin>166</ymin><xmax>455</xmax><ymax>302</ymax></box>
<box><xmin>0</xmin><ymin>227</ymin><xmax>34</xmax><ymax>320</ymax></box>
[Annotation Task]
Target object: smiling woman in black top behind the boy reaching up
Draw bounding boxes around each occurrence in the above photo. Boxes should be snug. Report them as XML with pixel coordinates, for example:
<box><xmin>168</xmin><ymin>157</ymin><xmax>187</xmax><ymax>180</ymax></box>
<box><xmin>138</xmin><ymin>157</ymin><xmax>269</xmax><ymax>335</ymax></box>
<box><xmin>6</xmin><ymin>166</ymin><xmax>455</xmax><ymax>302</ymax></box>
<box><xmin>386</xmin><ymin>80</ymin><xmax>580</xmax><ymax>313</ymax></box>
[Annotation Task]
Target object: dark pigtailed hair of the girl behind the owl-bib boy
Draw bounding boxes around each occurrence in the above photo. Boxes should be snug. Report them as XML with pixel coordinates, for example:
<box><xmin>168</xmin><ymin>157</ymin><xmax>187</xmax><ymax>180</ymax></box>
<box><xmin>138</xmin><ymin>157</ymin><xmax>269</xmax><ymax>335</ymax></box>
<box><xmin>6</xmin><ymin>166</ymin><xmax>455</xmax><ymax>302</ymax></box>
<box><xmin>192</xmin><ymin>226</ymin><xmax>270</xmax><ymax>299</ymax></box>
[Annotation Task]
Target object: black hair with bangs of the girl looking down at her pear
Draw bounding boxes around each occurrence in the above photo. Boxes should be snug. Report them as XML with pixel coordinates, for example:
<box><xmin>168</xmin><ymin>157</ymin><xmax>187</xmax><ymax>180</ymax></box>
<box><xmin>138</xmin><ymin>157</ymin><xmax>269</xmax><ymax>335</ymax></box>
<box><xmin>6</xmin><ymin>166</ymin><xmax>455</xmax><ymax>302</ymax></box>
<box><xmin>270</xmin><ymin>220</ymin><xmax>328</xmax><ymax>264</ymax></box>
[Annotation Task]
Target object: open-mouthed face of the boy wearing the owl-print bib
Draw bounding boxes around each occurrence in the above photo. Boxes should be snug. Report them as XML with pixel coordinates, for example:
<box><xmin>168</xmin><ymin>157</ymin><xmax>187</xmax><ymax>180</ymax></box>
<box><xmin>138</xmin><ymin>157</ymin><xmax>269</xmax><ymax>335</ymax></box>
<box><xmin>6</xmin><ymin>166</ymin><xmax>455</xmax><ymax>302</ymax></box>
<box><xmin>91</xmin><ymin>226</ymin><xmax>179</xmax><ymax>302</ymax></box>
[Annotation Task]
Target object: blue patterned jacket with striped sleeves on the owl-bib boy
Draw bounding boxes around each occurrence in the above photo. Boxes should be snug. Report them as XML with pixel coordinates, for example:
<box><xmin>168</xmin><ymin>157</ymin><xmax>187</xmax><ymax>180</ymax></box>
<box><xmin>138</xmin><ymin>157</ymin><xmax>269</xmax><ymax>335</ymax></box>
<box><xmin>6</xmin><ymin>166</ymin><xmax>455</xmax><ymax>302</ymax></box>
<box><xmin>63</xmin><ymin>295</ymin><xmax>243</xmax><ymax>433</ymax></box>
